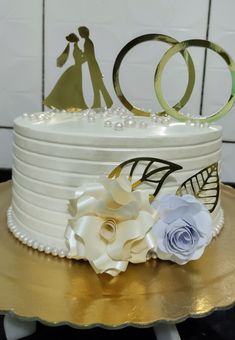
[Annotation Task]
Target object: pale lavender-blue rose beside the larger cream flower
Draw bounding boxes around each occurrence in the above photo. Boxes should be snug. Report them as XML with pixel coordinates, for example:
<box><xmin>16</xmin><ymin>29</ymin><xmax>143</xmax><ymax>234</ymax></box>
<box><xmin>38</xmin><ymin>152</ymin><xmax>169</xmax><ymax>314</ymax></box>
<box><xmin>152</xmin><ymin>195</ymin><xmax>212</xmax><ymax>265</ymax></box>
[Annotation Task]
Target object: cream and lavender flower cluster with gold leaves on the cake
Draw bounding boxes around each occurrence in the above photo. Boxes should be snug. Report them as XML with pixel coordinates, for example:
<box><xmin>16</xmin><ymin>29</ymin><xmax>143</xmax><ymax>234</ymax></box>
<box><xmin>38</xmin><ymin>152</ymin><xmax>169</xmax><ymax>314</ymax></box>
<box><xmin>65</xmin><ymin>157</ymin><xmax>219</xmax><ymax>276</ymax></box>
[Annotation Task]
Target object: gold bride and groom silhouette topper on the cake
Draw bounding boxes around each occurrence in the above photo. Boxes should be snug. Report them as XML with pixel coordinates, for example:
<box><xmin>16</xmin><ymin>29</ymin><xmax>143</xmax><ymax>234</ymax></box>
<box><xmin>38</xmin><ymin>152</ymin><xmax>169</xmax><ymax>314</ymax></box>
<box><xmin>44</xmin><ymin>26</ymin><xmax>113</xmax><ymax>111</ymax></box>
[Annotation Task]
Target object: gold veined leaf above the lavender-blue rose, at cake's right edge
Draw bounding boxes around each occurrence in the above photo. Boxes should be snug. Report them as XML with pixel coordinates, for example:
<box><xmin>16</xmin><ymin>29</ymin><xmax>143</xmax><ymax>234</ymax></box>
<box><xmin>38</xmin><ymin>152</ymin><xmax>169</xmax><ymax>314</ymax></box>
<box><xmin>176</xmin><ymin>163</ymin><xmax>220</xmax><ymax>213</ymax></box>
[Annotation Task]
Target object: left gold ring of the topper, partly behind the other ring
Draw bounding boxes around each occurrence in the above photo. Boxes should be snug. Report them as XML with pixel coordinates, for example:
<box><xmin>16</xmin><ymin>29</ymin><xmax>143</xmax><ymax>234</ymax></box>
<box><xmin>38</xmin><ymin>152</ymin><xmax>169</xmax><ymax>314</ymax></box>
<box><xmin>113</xmin><ymin>33</ymin><xmax>195</xmax><ymax>116</ymax></box>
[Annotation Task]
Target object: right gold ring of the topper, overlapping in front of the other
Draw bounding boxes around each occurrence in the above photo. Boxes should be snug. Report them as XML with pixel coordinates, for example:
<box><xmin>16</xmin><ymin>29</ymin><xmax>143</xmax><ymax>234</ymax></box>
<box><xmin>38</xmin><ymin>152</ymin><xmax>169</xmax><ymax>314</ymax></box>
<box><xmin>154</xmin><ymin>39</ymin><xmax>235</xmax><ymax>123</ymax></box>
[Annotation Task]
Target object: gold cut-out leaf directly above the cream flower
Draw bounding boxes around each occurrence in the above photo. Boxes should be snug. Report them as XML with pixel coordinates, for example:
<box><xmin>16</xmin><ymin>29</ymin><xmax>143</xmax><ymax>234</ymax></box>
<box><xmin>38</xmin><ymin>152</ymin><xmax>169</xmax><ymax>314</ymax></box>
<box><xmin>108</xmin><ymin>157</ymin><xmax>182</xmax><ymax>201</ymax></box>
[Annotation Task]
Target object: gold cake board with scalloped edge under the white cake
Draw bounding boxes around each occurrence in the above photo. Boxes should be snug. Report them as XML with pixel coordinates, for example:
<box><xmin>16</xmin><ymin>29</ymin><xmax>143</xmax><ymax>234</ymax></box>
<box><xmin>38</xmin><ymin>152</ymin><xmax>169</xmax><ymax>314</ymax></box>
<box><xmin>0</xmin><ymin>182</ymin><xmax>235</xmax><ymax>328</ymax></box>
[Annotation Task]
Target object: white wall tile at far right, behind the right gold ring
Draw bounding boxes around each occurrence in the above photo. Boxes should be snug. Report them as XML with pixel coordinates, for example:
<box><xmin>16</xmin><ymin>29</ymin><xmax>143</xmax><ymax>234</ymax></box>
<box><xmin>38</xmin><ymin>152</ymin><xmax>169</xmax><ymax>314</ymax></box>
<box><xmin>204</xmin><ymin>0</ymin><xmax>235</xmax><ymax>143</ymax></box>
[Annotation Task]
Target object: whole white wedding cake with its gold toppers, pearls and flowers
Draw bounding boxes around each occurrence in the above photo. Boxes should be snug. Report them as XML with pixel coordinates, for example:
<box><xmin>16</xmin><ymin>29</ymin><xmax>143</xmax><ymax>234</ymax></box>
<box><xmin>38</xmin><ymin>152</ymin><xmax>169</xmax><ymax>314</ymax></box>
<box><xmin>8</xmin><ymin>33</ymin><xmax>235</xmax><ymax>276</ymax></box>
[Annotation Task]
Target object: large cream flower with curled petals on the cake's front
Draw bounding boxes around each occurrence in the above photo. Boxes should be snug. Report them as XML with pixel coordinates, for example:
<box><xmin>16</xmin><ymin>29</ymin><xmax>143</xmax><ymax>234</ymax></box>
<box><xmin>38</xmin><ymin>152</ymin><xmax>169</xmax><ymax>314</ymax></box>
<box><xmin>65</xmin><ymin>176</ymin><xmax>157</xmax><ymax>276</ymax></box>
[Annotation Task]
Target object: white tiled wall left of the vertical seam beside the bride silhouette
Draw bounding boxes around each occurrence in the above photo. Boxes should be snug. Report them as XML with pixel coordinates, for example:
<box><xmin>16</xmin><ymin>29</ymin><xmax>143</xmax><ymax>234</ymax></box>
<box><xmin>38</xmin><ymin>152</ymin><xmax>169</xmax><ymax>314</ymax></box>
<box><xmin>0</xmin><ymin>0</ymin><xmax>42</xmax><ymax>168</ymax></box>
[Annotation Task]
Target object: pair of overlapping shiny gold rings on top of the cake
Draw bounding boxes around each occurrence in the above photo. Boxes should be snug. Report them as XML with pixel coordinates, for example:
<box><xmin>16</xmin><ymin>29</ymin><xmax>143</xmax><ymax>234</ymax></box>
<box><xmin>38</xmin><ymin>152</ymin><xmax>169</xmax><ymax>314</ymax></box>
<box><xmin>113</xmin><ymin>33</ymin><xmax>235</xmax><ymax>122</ymax></box>
